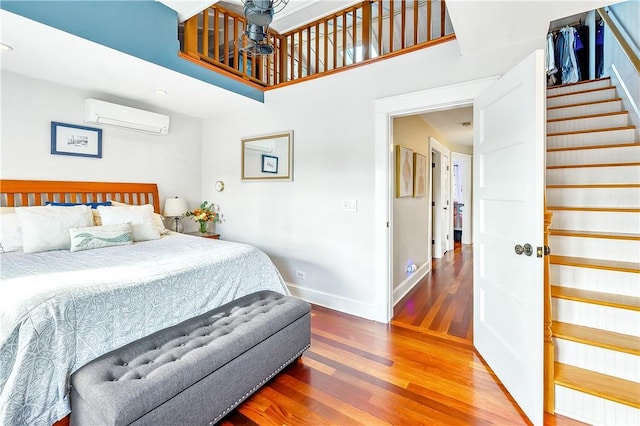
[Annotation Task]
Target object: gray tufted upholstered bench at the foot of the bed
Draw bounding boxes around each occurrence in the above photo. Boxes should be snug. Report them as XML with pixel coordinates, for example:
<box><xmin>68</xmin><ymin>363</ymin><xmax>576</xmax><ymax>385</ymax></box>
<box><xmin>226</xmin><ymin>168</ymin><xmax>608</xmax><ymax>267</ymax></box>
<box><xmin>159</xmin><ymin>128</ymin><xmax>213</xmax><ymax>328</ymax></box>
<box><xmin>71</xmin><ymin>291</ymin><xmax>311</xmax><ymax>426</ymax></box>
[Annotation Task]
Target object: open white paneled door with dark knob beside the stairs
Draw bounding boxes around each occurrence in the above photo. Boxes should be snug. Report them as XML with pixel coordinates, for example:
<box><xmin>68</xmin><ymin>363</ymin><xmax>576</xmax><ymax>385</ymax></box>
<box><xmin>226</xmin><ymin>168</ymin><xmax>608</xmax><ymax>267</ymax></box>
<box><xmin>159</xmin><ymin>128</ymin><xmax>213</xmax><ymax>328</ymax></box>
<box><xmin>473</xmin><ymin>50</ymin><xmax>545</xmax><ymax>425</ymax></box>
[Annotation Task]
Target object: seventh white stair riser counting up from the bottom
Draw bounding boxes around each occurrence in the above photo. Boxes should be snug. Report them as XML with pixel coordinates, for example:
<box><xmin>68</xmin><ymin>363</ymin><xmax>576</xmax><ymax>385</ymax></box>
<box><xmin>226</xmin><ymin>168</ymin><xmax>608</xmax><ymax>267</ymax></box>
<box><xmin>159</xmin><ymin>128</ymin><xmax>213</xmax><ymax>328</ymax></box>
<box><xmin>546</xmin><ymin>188</ymin><xmax>640</xmax><ymax>209</ymax></box>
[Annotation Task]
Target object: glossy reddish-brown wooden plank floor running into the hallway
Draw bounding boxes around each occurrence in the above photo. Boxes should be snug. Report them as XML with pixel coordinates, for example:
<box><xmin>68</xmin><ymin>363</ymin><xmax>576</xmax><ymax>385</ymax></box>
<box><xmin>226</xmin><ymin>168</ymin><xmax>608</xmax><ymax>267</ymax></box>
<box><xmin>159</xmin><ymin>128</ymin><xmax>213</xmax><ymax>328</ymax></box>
<box><xmin>221</xmin><ymin>246</ymin><xmax>581</xmax><ymax>425</ymax></box>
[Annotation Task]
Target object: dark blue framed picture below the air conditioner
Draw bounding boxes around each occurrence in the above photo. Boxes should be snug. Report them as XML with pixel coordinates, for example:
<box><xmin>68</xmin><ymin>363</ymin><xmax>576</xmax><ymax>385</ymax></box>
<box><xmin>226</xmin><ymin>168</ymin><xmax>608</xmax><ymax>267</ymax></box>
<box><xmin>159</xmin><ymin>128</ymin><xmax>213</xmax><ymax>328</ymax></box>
<box><xmin>51</xmin><ymin>121</ymin><xmax>102</xmax><ymax>158</ymax></box>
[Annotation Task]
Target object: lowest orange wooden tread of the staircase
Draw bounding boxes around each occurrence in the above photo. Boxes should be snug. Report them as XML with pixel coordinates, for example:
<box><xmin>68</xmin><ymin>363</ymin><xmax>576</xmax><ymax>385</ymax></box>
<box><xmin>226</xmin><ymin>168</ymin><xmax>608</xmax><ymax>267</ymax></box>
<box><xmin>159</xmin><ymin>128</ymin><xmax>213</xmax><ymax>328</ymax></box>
<box><xmin>554</xmin><ymin>362</ymin><xmax>640</xmax><ymax>408</ymax></box>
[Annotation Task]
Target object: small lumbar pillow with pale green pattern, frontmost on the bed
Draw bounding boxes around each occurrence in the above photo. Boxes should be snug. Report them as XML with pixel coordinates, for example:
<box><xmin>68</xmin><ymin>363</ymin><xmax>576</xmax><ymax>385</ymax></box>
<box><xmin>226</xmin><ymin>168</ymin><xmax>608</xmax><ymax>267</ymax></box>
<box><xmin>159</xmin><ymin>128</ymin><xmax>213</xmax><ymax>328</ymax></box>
<box><xmin>69</xmin><ymin>223</ymin><xmax>133</xmax><ymax>251</ymax></box>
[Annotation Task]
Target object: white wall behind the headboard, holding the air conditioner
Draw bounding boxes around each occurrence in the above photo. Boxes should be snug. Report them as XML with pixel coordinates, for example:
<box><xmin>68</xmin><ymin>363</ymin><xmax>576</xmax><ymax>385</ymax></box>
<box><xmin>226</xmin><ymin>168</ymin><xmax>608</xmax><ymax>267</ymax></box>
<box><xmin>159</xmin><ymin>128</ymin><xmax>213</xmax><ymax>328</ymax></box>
<box><xmin>0</xmin><ymin>71</ymin><xmax>202</xmax><ymax>218</ymax></box>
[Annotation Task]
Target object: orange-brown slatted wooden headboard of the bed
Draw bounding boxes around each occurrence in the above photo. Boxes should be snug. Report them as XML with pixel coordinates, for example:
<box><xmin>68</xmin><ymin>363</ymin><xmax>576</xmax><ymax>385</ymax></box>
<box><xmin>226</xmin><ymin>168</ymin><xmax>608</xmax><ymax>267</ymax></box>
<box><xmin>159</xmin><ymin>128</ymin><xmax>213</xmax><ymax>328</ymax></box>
<box><xmin>0</xmin><ymin>179</ymin><xmax>160</xmax><ymax>213</ymax></box>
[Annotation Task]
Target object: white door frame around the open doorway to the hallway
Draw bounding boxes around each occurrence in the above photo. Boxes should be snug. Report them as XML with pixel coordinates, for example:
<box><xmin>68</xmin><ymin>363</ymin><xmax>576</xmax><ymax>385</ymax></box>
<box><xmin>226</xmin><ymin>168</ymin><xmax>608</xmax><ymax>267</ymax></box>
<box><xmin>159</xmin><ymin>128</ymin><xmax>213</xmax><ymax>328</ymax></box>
<box><xmin>370</xmin><ymin>75</ymin><xmax>499</xmax><ymax>323</ymax></box>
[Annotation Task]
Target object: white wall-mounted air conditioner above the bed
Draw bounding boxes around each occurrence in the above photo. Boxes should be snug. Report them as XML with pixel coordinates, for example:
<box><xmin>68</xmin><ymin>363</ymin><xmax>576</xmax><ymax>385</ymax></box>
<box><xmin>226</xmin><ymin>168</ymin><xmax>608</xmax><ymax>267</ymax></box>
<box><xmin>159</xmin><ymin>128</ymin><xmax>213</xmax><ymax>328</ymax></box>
<box><xmin>84</xmin><ymin>99</ymin><xmax>169</xmax><ymax>135</ymax></box>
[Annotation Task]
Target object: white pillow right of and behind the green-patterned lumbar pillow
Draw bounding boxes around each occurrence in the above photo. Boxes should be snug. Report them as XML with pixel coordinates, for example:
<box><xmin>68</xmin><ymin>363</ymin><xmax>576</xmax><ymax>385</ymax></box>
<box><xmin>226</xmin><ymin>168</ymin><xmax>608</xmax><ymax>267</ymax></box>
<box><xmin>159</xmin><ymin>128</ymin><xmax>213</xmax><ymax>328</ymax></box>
<box><xmin>98</xmin><ymin>204</ymin><xmax>160</xmax><ymax>241</ymax></box>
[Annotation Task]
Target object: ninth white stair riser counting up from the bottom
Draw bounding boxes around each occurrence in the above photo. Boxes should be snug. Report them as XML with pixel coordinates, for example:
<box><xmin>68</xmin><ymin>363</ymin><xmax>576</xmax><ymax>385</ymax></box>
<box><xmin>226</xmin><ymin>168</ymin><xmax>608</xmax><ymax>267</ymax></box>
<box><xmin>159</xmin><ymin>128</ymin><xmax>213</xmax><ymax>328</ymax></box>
<box><xmin>547</xmin><ymin>146</ymin><xmax>640</xmax><ymax>166</ymax></box>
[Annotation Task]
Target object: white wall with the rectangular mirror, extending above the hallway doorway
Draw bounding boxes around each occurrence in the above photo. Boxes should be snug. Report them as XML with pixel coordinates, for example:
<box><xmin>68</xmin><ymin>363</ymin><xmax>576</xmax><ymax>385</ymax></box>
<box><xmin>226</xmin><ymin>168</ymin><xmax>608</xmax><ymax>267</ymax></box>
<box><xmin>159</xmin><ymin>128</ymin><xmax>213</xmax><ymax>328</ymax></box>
<box><xmin>202</xmin><ymin>37</ymin><xmax>544</xmax><ymax>320</ymax></box>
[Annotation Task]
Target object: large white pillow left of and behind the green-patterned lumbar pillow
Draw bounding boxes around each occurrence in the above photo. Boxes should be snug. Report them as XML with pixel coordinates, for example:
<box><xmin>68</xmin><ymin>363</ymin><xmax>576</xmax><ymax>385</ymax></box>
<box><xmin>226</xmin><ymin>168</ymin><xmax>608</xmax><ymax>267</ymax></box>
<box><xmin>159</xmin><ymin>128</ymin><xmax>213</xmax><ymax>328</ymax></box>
<box><xmin>16</xmin><ymin>206</ymin><xmax>93</xmax><ymax>253</ymax></box>
